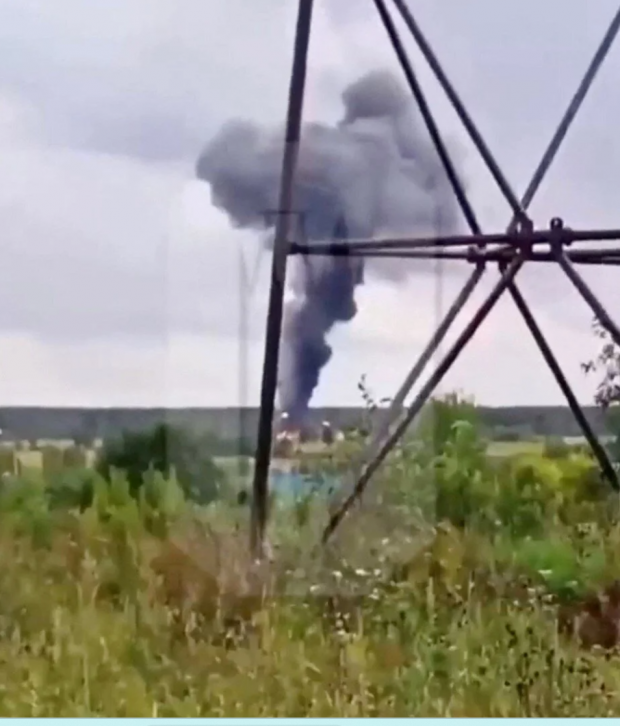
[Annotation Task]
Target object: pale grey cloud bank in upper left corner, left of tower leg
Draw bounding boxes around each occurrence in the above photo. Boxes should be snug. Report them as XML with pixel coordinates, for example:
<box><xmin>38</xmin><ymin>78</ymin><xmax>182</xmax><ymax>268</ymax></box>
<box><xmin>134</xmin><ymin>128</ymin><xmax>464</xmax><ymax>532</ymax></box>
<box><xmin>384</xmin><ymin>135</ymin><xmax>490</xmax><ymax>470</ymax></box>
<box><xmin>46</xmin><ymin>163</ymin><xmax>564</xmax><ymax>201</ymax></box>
<box><xmin>0</xmin><ymin>0</ymin><xmax>289</xmax><ymax>159</ymax></box>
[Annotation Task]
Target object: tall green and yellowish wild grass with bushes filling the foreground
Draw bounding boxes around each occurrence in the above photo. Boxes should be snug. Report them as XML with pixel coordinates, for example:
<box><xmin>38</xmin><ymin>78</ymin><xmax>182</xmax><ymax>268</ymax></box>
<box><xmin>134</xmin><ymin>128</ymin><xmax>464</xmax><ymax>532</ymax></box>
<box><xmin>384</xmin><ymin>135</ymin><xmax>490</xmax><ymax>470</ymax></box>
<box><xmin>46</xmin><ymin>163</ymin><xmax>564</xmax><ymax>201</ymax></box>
<box><xmin>0</xmin><ymin>406</ymin><xmax>620</xmax><ymax>717</ymax></box>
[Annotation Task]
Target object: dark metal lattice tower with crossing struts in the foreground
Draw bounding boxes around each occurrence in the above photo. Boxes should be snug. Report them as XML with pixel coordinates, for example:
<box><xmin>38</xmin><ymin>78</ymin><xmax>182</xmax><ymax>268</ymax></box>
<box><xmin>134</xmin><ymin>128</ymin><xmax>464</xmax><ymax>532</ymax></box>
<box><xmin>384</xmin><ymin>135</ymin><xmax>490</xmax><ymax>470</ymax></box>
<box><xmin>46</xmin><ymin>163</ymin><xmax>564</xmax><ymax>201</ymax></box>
<box><xmin>252</xmin><ymin>0</ymin><xmax>620</xmax><ymax>556</ymax></box>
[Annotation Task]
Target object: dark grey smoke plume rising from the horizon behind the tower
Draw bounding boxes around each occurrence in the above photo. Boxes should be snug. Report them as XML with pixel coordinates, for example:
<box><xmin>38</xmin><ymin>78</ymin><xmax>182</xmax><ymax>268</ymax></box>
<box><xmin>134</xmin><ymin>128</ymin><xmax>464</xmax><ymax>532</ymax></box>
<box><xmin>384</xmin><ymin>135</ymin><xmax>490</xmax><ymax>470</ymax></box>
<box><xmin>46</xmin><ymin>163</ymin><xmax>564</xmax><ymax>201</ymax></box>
<box><xmin>197</xmin><ymin>71</ymin><xmax>458</xmax><ymax>425</ymax></box>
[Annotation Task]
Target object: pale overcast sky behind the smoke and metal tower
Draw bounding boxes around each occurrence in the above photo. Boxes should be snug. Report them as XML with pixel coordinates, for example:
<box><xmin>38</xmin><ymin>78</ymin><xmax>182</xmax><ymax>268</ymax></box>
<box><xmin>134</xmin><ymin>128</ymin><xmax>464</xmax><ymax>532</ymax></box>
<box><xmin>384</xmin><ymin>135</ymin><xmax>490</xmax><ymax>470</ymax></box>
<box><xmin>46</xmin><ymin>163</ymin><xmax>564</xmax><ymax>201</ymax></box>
<box><xmin>0</xmin><ymin>0</ymin><xmax>620</xmax><ymax>406</ymax></box>
